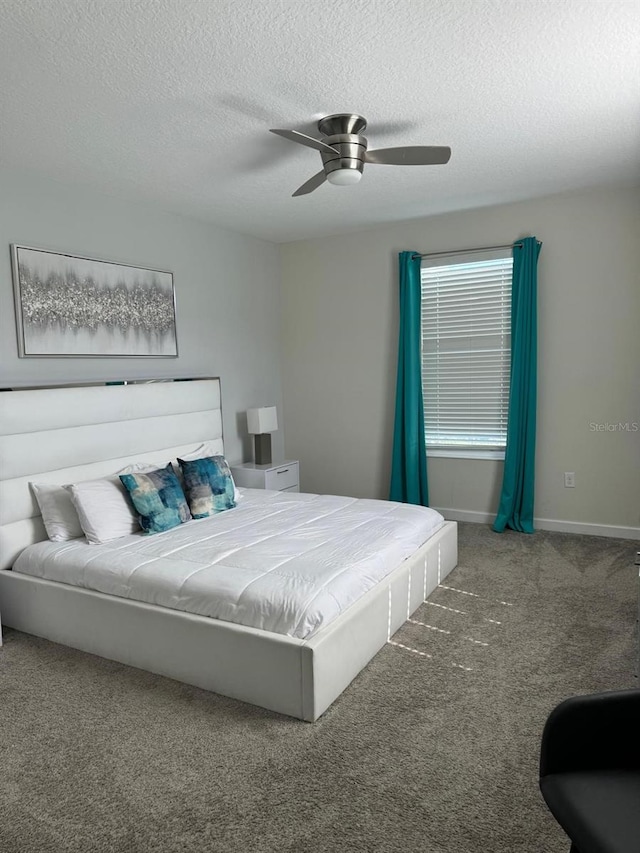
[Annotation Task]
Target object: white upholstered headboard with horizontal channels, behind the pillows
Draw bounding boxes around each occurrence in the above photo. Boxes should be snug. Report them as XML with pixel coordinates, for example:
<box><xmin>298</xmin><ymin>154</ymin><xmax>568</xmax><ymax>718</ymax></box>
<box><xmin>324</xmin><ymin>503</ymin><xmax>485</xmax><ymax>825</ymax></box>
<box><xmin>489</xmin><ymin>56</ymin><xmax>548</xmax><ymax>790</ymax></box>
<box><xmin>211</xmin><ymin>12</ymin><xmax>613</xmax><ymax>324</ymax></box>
<box><xmin>0</xmin><ymin>379</ymin><xmax>224</xmax><ymax>569</ymax></box>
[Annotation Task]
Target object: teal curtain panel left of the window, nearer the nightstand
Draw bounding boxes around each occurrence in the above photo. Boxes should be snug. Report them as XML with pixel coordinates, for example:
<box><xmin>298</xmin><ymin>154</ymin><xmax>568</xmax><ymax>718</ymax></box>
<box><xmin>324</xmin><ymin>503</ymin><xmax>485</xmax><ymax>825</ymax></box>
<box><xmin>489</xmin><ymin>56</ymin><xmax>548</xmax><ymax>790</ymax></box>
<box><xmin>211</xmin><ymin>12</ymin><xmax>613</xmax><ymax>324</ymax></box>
<box><xmin>389</xmin><ymin>252</ymin><xmax>429</xmax><ymax>506</ymax></box>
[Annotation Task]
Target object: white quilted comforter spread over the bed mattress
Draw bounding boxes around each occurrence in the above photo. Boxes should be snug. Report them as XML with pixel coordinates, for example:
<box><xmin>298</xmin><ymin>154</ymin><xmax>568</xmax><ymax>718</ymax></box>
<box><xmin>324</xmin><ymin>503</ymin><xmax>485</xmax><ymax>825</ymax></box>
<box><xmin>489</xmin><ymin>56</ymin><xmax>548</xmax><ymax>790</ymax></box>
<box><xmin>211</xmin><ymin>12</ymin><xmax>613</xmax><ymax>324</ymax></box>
<box><xmin>13</xmin><ymin>489</ymin><xmax>444</xmax><ymax>639</ymax></box>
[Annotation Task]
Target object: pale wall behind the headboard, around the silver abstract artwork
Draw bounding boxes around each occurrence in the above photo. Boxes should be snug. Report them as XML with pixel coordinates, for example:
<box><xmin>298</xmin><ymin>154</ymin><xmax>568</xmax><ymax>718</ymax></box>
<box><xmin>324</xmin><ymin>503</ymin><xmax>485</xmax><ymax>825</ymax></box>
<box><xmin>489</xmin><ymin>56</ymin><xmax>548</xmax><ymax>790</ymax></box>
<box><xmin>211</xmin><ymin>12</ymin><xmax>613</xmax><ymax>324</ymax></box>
<box><xmin>0</xmin><ymin>171</ymin><xmax>283</xmax><ymax>461</ymax></box>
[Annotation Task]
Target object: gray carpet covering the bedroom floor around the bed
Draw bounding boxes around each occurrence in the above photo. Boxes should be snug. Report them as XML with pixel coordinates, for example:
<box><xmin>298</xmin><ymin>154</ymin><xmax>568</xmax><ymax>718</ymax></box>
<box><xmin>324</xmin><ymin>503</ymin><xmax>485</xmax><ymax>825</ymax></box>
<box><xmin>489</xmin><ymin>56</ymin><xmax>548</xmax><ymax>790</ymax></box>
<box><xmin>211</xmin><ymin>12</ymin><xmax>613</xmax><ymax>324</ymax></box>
<box><xmin>0</xmin><ymin>524</ymin><xmax>637</xmax><ymax>853</ymax></box>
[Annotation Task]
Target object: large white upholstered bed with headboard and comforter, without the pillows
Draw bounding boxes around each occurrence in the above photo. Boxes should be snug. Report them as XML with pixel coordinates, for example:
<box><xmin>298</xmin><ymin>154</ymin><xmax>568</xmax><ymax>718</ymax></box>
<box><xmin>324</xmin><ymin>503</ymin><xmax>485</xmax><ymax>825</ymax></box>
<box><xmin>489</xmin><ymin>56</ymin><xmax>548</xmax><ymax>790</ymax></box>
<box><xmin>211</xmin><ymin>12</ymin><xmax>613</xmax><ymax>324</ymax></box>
<box><xmin>0</xmin><ymin>379</ymin><xmax>457</xmax><ymax>721</ymax></box>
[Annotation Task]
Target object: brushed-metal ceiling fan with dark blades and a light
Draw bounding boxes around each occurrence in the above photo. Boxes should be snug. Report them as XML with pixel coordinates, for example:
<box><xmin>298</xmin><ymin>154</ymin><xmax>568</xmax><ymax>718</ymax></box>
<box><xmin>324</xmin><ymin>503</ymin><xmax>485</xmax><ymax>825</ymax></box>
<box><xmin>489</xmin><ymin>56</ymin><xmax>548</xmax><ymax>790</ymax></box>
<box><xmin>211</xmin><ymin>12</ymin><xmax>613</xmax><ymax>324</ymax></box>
<box><xmin>271</xmin><ymin>113</ymin><xmax>451</xmax><ymax>196</ymax></box>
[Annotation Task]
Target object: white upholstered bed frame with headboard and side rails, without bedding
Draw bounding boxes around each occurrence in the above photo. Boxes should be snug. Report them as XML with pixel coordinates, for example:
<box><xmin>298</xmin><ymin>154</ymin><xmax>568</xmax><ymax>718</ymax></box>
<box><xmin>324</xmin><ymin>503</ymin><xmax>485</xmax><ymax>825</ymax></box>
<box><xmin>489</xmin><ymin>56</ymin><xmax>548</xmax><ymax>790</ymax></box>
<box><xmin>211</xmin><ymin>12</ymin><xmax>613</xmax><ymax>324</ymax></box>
<box><xmin>0</xmin><ymin>379</ymin><xmax>457</xmax><ymax>721</ymax></box>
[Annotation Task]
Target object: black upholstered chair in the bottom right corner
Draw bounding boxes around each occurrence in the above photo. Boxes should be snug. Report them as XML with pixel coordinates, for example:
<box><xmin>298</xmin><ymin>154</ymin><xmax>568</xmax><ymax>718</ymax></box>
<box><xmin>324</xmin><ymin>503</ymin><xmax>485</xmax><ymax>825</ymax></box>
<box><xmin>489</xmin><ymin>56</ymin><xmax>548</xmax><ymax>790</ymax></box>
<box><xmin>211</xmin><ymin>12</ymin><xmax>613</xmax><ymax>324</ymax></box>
<box><xmin>540</xmin><ymin>690</ymin><xmax>640</xmax><ymax>853</ymax></box>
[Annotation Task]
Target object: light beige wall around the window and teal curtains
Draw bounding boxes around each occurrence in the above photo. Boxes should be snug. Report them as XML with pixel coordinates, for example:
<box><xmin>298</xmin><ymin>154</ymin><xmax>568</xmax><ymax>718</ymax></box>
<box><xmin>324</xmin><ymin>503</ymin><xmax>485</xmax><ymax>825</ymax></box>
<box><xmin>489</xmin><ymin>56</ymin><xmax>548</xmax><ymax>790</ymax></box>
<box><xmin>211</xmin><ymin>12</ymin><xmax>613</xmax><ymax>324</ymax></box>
<box><xmin>282</xmin><ymin>187</ymin><xmax>640</xmax><ymax>535</ymax></box>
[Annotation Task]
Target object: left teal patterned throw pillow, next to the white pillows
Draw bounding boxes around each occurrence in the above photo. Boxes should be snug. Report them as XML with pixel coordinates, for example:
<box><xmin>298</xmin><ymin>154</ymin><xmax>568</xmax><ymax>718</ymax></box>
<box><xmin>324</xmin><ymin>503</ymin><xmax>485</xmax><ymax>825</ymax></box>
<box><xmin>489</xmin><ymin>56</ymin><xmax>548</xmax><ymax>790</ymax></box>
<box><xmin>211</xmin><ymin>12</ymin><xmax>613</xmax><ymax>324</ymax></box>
<box><xmin>120</xmin><ymin>463</ymin><xmax>191</xmax><ymax>533</ymax></box>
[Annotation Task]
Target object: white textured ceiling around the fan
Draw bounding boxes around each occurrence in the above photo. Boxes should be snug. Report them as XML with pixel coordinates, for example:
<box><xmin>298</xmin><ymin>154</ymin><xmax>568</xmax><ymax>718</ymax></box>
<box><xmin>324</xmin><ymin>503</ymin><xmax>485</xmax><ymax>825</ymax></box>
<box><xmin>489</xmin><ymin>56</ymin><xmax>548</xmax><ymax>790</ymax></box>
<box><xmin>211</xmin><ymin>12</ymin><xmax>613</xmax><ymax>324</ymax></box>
<box><xmin>0</xmin><ymin>0</ymin><xmax>640</xmax><ymax>241</ymax></box>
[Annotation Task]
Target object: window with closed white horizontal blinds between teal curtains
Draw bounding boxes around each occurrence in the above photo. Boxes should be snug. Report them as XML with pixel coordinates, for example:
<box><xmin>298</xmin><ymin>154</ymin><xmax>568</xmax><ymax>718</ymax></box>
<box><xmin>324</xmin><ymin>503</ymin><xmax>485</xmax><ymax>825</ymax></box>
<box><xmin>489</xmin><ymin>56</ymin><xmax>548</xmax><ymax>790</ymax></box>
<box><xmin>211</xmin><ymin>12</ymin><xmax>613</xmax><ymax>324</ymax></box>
<box><xmin>421</xmin><ymin>256</ymin><xmax>513</xmax><ymax>456</ymax></box>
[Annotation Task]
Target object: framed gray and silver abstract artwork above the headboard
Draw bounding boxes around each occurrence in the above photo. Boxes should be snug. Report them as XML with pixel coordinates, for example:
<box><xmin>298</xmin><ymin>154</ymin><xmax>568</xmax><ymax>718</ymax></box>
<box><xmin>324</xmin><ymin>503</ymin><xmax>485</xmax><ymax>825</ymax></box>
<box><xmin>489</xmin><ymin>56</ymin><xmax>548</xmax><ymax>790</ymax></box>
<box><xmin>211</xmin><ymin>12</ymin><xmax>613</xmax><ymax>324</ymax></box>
<box><xmin>11</xmin><ymin>245</ymin><xmax>178</xmax><ymax>358</ymax></box>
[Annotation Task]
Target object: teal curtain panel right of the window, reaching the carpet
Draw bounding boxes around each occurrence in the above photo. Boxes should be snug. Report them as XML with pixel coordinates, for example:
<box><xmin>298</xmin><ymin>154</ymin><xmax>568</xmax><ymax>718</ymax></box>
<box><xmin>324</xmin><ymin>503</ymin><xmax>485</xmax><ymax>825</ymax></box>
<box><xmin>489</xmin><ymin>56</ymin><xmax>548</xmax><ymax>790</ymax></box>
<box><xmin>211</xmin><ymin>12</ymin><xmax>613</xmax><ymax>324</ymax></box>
<box><xmin>493</xmin><ymin>237</ymin><xmax>542</xmax><ymax>533</ymax></box>
